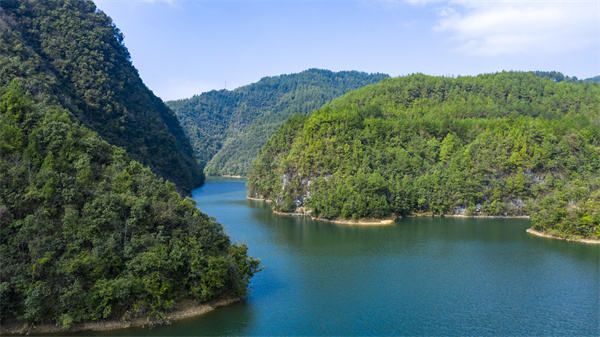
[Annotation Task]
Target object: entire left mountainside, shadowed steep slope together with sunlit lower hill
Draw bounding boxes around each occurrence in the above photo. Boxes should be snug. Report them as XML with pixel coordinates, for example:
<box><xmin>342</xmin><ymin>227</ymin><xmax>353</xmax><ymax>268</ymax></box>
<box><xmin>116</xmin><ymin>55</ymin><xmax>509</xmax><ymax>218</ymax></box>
<box><xmin>0</xmin><ymin>0</ymin><xmax>258</xmax><ymax>332</ymax></box>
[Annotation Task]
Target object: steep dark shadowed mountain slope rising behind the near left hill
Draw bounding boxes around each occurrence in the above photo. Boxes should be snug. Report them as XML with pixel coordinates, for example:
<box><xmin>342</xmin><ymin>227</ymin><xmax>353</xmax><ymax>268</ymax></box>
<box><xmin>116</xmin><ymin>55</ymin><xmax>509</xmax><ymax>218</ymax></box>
<box><xmin>0</xmin><ymin>0</ymin><xmax>203</xmax><ymax>190</ymax></box>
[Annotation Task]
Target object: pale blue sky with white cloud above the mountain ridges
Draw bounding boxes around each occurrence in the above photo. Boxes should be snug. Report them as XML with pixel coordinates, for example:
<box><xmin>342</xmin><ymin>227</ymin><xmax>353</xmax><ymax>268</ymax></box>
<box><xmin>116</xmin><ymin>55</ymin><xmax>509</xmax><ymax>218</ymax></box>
<box><xmin>95</xmin><ymin>0</ymin><xmax>600</xmax><ymax>100</ymax></box>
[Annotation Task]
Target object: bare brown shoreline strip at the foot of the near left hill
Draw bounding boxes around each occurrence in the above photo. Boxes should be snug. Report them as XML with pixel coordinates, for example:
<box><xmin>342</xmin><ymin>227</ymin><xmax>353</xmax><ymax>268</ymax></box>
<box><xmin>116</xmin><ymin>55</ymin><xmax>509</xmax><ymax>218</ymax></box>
<box><xmin>0</xmin><ymin>297</ymin><xmax>242</xmax><ymax>336</ymax></box>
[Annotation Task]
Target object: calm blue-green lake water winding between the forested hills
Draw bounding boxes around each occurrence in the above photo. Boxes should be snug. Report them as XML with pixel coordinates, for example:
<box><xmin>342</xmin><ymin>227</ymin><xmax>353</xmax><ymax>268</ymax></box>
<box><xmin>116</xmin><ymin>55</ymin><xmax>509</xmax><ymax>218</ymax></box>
<box><xmin>101</xmin><ymin>179</ymin><xmax>600</xmax><ymax>336</ymax></box>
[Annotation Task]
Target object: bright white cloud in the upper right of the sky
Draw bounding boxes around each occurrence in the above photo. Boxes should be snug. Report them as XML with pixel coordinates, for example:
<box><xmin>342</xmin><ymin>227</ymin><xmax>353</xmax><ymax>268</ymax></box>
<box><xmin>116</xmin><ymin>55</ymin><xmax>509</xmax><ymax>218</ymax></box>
<box><xmin>406</xmin><ymin>0</ymin><xmax>600</xmax><ymax>55</ymax></box>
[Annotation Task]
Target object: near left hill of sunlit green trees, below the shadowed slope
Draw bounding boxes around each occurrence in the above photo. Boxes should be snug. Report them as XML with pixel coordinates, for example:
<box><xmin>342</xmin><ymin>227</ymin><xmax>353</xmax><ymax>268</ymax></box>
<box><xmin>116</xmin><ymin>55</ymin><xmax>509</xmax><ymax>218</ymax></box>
<box><xmin>0</xmin><ymin>82</ymin><xmax>258</xmax><ymax>328</ymax></box>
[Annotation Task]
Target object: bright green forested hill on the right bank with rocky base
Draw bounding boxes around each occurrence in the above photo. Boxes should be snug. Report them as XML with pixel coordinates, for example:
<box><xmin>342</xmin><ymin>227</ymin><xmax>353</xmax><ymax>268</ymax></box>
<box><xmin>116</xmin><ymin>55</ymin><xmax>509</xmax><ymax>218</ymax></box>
<box><xmin>248</xmin><ymin>72</ymin><xmax>600</xmax><ymax>238</ymax></box>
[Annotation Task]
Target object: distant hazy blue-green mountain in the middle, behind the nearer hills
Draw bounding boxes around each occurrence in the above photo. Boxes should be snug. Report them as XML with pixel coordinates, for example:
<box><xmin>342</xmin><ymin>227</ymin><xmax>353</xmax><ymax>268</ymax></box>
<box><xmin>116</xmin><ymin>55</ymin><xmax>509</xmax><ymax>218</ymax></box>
<box><xmin>167</xmin><ymin>69</ymin><xmax>387</xmax><ymax>176</ymax></box>
